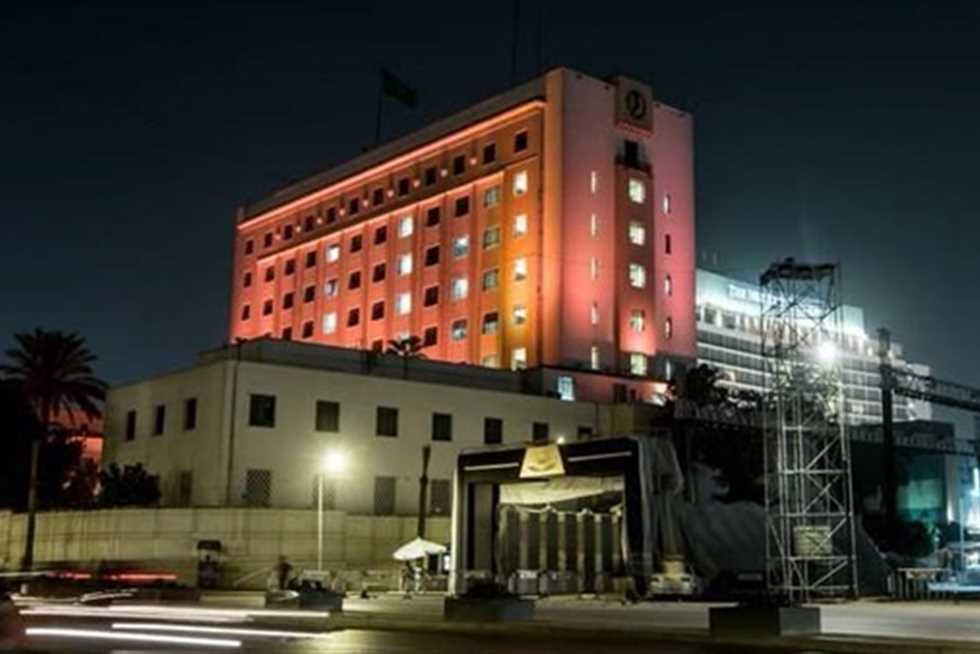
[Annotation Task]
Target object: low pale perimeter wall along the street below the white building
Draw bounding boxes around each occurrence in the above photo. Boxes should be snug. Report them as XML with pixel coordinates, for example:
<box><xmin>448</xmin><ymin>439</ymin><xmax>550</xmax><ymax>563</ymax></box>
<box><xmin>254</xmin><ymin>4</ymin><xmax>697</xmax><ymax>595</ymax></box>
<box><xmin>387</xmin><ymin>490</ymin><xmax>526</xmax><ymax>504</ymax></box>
<box><xmin>0</xmin><ymin>509</ymin><xmax>449</xmax><ymax>588</ymax></box>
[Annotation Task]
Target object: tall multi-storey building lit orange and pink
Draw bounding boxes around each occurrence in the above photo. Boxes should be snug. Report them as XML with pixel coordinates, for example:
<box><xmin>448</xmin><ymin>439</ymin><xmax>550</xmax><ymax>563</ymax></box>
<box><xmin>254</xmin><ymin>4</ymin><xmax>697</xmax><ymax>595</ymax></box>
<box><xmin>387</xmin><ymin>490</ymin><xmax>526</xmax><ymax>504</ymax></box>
<box><xmin>229</xmin><ymin>68</ymin><xmax>696</xmax><ymax>379</ymax></box>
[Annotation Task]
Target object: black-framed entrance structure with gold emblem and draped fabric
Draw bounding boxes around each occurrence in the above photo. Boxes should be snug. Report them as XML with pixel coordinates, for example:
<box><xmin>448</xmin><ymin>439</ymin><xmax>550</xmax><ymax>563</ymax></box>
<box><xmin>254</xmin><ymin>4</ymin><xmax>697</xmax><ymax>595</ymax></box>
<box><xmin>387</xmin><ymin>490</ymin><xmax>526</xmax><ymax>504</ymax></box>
<box><xmin>450</xmin><ymin>435</ymin><xmax>678</xmax><ymax>596</ymax></box>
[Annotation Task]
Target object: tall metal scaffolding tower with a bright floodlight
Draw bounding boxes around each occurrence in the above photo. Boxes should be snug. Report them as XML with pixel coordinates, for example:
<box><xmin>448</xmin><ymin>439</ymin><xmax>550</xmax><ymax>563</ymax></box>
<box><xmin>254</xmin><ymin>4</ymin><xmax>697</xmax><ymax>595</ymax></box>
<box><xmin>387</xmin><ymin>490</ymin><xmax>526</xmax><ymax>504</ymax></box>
<box><xmin>760</xmin><ymin>259</ymin><xmax>857</xmax><ymax>604</ymax></box>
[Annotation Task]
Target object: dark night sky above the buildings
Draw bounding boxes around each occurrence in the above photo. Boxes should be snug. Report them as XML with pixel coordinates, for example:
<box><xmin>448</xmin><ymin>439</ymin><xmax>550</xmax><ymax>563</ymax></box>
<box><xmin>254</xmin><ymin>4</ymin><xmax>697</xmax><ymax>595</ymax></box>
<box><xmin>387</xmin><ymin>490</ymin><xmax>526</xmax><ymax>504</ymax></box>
<box><xmin>0</xmin><ymin>1</ymin><xmax>980</xmax><ymax>436</ymax></box>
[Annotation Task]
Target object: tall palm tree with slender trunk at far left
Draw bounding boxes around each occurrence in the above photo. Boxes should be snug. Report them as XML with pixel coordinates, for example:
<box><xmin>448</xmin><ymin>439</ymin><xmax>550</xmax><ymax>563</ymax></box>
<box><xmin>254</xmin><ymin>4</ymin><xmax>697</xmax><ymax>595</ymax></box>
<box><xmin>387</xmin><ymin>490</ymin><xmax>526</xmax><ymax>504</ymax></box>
<box><xmin>0</xmin><ymin>328</ymin><xmax>106</xmax><ymax>570</ymax></box>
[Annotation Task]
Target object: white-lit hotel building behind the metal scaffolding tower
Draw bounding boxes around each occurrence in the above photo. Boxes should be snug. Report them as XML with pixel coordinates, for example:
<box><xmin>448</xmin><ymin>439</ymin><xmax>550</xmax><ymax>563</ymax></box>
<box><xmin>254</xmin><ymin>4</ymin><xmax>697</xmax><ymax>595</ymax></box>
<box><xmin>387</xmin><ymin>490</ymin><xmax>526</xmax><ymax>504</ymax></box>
<box><xmin>696</xmin><ymin>269</ymin><xmax>932</xmax><ymax>424</ymax></box>
